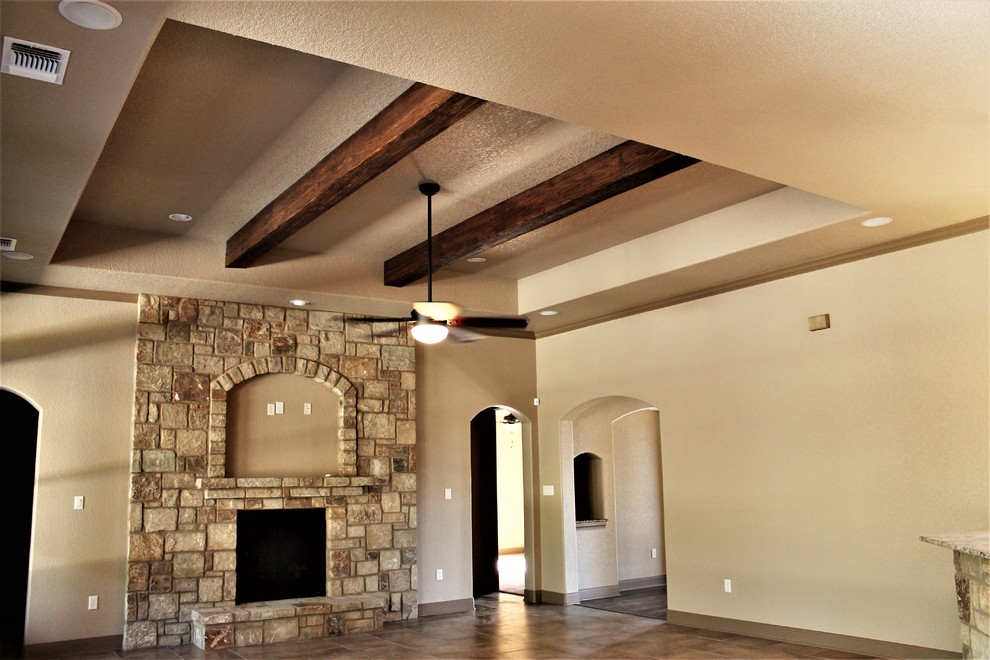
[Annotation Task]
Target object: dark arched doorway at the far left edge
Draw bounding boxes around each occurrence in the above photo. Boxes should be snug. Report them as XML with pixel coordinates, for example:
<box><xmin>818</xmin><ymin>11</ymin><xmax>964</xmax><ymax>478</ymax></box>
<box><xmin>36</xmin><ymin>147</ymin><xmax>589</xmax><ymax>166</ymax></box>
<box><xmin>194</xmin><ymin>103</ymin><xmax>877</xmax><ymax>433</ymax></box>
<box><xmin>0</xmin><ymin>389</ymin><xmax>38</xmax><ymax>658</ymax></box>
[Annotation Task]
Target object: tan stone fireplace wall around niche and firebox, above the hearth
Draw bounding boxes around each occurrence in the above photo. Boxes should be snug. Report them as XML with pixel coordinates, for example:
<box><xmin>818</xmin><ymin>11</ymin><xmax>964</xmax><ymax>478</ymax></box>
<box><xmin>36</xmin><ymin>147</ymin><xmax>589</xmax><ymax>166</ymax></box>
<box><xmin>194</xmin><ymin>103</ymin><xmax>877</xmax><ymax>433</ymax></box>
<box><xmin>124</xmin><ymin>295</ymin><xmax>417</xmax><ymax>649</ymax></box>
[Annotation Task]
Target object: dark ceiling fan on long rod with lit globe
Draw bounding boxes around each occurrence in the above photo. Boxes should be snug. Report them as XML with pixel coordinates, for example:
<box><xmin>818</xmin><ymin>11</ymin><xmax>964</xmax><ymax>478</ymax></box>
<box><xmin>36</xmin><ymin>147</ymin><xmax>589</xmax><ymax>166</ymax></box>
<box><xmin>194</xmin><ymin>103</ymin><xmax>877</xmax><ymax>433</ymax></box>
<box><xmin>363</xmin><ymin>181</ymin><xmax>529</xmax><ymax>344</ymax></box>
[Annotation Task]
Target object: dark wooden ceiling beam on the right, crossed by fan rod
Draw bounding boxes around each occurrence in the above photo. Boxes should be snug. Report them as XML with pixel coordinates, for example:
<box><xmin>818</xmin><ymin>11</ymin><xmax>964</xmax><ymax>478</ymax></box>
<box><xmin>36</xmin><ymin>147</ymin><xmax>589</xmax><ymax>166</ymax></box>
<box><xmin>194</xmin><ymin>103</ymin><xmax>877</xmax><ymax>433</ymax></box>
<box><xmin>385</xmin><ymin>141</ymin><xmax>698</xmax><ymax>287</ymax></box>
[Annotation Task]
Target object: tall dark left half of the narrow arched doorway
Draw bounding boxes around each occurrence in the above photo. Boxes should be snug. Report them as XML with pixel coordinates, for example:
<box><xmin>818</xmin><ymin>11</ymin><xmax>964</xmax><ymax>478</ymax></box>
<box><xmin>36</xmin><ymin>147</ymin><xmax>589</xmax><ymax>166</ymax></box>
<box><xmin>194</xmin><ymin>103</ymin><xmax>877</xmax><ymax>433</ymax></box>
<box><xmin>471</xmin><ymin>408</ymin><xmax>498</xmax><ymax>598</ymax></box>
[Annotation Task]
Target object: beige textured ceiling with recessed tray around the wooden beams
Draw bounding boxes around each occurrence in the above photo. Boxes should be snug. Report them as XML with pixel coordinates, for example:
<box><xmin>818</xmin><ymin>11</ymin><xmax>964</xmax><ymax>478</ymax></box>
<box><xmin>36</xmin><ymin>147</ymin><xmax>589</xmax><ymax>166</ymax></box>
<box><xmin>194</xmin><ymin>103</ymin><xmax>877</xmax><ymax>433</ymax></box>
<box><xmin>0</xmin><ymin>0</ymin><xmax>990</xmax><ymax>334</ymax></box>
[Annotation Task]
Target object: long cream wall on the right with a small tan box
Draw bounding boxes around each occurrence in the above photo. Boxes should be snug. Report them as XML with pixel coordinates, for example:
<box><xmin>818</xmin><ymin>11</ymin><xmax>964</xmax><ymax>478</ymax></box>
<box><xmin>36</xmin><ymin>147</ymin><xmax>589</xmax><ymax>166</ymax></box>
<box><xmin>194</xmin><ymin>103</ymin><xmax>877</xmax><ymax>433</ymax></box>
<box><xmin>537</xmin><ymin>232</ymin><xmax>990</xmax><ymax>650</ymax></box>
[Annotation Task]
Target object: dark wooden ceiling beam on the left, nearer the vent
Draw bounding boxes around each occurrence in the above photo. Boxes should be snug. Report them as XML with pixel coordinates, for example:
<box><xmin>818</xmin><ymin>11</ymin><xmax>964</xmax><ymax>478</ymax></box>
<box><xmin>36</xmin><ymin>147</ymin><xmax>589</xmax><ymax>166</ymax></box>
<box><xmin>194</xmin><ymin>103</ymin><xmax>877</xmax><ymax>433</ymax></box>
<box><xmin>226</xmin><ymin>83</ymin><xmax>484</xmax><ymax>268</ymax></box>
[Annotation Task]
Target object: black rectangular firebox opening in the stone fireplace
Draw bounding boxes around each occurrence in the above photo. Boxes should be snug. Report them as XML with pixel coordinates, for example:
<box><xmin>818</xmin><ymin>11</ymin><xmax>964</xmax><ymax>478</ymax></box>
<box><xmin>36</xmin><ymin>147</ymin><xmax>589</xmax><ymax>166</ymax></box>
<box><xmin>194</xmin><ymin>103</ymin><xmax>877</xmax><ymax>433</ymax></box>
<box><xmin>235</xmin><ymin>509</ymin><xmax>327</xmax><ymax>605</ymax></box>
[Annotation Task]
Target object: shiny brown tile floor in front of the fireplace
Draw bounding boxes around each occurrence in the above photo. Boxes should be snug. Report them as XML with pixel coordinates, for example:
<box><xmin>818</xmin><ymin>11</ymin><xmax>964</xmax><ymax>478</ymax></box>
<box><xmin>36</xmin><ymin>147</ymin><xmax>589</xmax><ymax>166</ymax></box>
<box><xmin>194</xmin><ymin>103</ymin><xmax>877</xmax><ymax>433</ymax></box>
<box><xmin>33</xmin><ymin>594</ymin><xmax>884</xmax><ymax>660</ymax></box>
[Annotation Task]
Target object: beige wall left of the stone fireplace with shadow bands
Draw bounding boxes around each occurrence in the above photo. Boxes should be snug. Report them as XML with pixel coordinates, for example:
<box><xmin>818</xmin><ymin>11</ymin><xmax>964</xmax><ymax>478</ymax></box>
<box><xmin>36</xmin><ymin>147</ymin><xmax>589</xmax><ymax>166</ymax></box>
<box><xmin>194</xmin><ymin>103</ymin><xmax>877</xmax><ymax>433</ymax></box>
<box><xmin>0</xmin><ymin>293</ymin><xmax>137</xmax><ymax>644</ymax></box>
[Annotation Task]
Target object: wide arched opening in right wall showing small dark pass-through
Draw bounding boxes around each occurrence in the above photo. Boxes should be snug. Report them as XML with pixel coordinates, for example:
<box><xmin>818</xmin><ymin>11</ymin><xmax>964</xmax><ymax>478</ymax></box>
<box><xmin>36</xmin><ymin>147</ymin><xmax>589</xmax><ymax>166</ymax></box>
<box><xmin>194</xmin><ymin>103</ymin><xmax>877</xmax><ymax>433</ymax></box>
<box><xmin>560</xmin><ymin>397</ymin><xmax>666</xmax><ymax>618</ymax></box>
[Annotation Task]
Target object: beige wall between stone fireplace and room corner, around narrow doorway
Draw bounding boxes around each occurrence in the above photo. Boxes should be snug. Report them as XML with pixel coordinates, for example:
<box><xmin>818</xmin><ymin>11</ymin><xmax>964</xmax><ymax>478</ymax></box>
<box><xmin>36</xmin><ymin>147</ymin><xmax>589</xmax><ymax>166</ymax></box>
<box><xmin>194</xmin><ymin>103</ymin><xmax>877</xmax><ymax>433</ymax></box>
<box><xmin>416</xmin><ymin>338</ymin><xmax>539</xmax><ymax>604</ymax></box>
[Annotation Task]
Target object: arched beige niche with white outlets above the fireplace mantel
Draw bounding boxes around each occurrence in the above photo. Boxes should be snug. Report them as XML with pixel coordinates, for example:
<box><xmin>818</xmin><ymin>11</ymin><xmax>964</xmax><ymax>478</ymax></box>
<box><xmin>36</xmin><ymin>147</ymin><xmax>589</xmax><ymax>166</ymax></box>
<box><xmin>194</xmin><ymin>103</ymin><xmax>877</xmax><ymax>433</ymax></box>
<box><xmin>226</xmin><ymin>374</ymin><xmax>342</xmax><ymax>477</ymax></box>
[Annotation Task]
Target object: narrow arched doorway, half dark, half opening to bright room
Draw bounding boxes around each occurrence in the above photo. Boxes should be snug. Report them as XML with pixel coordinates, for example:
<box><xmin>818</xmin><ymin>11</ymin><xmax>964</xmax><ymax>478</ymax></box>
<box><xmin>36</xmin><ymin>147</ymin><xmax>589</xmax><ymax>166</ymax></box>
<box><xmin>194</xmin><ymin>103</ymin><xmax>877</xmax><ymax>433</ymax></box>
<box><xmin>471</xmin><ymin>406</ymin><xmax>533</xmax><ymax>600</ymax></box>
